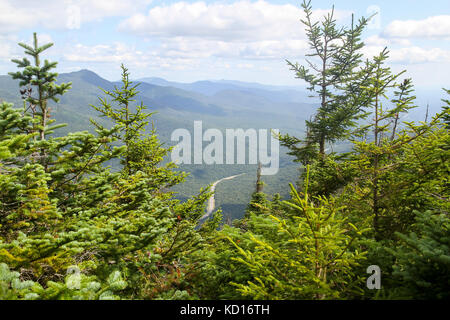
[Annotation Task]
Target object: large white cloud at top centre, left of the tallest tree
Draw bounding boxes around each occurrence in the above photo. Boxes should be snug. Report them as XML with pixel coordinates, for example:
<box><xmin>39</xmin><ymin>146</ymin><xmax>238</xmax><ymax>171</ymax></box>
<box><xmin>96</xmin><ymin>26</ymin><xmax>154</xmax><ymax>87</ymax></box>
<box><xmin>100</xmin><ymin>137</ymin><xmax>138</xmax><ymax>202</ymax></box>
<box><xmin>113</xmin><ymin>0</ymin><xmax>351</xmax><ymax>65</ymax></box>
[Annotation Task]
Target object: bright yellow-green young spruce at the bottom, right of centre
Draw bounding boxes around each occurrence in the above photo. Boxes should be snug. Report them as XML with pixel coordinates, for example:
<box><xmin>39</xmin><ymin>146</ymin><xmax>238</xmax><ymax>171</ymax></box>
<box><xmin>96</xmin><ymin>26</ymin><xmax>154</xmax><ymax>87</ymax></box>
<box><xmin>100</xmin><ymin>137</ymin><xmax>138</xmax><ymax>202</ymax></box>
<box><xmin>229</xmin><ymin>169</ymin><xmax>364</xmax><ymax>299</ymax></box>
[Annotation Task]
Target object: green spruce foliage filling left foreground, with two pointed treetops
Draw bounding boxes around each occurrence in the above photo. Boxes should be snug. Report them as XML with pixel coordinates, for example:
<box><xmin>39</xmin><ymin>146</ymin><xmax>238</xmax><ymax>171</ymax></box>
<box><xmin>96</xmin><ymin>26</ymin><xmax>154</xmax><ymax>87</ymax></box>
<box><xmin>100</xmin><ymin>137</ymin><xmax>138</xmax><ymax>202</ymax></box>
<box><xmin>0</xmin><ymin>37</ymin><xmax>209</xmax><ymax>299</ymax></box>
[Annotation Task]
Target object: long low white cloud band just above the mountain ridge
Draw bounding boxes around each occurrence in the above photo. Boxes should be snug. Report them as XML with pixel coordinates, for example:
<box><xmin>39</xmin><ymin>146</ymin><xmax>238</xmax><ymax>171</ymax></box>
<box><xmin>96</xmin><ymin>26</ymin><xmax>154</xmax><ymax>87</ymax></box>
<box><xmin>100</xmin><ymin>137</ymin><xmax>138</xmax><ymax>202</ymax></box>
<box><xmin>61</xmin><ymin>37</ymin><xmax>307</xmax><ymax>67</ymax></box>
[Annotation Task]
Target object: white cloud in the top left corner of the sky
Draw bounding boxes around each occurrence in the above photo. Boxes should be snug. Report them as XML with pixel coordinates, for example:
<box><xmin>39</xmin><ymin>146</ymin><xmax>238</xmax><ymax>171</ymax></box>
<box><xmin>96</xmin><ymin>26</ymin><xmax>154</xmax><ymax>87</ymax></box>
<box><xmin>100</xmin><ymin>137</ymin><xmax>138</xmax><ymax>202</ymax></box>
<box><xmin>0</xmin><ymin>0</ymin><xmax>151</xmax><ymax>33</ymax></box>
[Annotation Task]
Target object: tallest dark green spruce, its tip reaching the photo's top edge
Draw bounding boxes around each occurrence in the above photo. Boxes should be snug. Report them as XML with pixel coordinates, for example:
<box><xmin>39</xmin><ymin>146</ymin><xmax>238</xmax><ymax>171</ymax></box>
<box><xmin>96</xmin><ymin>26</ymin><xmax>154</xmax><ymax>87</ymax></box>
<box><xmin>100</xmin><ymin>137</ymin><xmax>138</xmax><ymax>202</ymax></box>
<box><xmin>280</xmin><ymin>0</ymin><xmax>368</xmax><ymax>164</ymax></box>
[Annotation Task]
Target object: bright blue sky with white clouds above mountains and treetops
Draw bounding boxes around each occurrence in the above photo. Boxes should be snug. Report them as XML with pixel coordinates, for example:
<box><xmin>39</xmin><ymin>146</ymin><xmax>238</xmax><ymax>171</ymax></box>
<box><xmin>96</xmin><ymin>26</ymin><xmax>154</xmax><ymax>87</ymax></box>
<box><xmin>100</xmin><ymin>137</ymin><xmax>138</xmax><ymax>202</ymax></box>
<box><xmin>0</xmin><ymin>0</ymin><xmax>450</xmax><ymax>88</ymax></box>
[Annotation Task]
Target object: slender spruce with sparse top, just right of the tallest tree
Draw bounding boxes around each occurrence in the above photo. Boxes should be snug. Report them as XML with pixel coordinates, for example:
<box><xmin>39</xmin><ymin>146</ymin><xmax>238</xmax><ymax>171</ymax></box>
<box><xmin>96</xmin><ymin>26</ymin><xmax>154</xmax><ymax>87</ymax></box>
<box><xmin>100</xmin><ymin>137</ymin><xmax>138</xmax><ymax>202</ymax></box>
<box><xmin>342</xmin><ymin>49</ymin><xmax>437</xmax><ymax>239</ymax></box>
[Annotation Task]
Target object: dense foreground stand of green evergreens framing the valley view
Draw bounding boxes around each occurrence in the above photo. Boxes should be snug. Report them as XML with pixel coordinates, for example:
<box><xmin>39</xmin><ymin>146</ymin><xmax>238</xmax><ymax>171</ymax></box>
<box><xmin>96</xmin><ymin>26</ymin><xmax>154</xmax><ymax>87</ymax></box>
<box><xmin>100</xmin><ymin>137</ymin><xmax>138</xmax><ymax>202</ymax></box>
<box><xmin>0</xmin><ymin>1</ymin><xmax>450</xmax><ymax>300</ymax></box>
